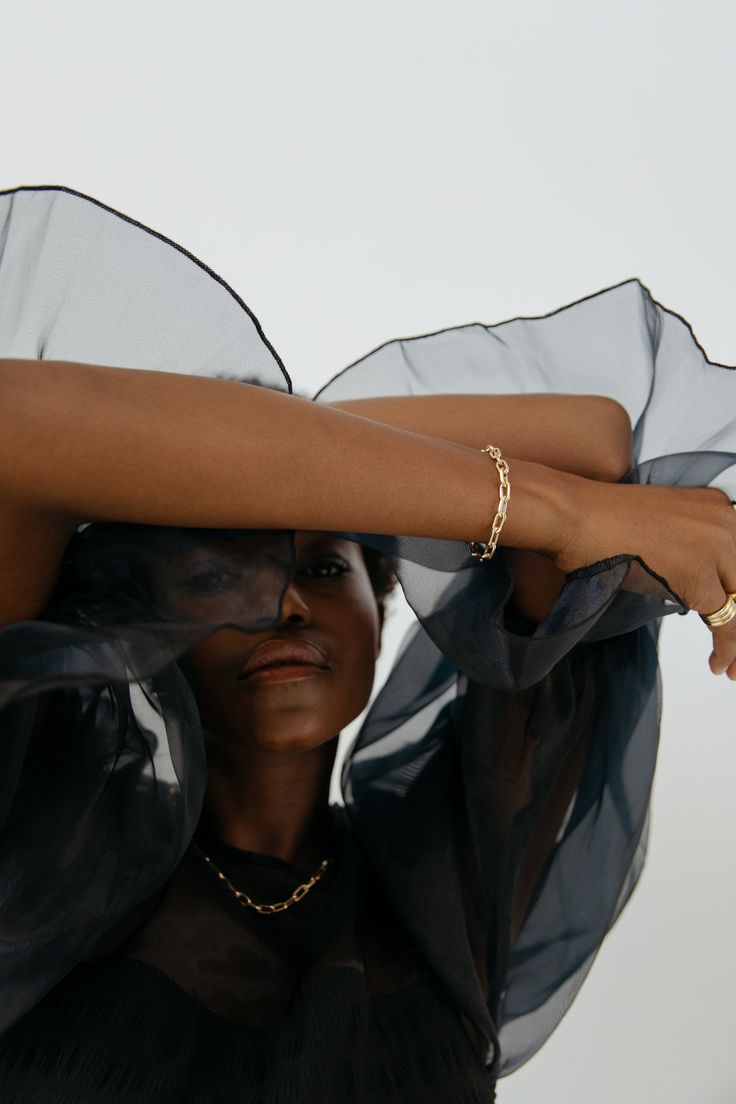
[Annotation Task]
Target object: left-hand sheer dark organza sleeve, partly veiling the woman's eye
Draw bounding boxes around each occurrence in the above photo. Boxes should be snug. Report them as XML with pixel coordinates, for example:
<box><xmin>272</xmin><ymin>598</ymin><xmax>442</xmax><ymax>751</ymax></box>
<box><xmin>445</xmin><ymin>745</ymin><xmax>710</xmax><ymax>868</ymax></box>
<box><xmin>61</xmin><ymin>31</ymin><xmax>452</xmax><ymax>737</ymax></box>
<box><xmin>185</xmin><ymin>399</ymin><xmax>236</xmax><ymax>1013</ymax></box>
<box><xmin>0</xmin><ymin>188</ymin><xmax>294</xmax><ymax>1030</ymax></box>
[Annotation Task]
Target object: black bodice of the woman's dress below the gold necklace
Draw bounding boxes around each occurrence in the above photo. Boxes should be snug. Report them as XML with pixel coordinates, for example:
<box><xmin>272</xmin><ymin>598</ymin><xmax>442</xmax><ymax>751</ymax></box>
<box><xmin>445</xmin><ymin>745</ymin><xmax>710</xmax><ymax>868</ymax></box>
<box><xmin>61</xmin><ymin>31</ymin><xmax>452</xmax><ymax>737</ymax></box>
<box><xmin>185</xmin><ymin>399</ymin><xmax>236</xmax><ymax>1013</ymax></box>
<box><xmin>0</xmin><ymin>806</ymin><xmax>491</xmax><ymax>1104</ymax></box>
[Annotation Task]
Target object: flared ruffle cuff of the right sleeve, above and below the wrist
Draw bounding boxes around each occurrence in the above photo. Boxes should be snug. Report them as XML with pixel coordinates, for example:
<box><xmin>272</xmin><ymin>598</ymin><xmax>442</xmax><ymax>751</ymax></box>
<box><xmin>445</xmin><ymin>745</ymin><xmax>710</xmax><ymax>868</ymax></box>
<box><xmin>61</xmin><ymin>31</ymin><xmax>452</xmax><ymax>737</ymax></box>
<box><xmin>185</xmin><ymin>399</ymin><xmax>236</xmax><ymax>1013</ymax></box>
<box><xmin>314</xmin><ymin>279</ymin><xmax>736</xmax><ymax>675</ymax></box>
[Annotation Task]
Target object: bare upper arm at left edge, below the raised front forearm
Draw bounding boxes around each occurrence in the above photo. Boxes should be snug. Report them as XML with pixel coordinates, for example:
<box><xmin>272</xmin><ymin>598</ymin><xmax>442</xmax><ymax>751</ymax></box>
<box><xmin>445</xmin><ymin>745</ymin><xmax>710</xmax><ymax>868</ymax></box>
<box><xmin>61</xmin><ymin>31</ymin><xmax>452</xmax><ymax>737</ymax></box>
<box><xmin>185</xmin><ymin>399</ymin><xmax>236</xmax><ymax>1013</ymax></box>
<box><xmin>0</xmin><ymin>498</ymin><xmax>76</xmax><ymax>628</ymax></box>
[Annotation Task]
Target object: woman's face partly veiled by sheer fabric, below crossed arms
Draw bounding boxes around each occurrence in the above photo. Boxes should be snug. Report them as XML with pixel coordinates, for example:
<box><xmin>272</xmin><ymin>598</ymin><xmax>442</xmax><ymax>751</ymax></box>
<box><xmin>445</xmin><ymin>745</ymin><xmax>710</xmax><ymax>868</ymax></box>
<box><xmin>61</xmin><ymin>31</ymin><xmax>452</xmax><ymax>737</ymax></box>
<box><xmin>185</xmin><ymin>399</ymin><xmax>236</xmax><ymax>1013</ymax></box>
<box><xmin>147</xmin><ymin>530</ymin><xmax>383</xmax><ymax>752</ymax></box>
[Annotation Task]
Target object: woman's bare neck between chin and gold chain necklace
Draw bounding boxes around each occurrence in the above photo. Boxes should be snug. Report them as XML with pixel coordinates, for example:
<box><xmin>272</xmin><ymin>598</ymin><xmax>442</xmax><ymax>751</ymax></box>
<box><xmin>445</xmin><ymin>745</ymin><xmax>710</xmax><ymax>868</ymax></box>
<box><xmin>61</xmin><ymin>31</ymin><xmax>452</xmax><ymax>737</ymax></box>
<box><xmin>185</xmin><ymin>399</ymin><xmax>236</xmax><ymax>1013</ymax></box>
<box><xmin>200</xmin><ymin>736</ymin><xmax>338</xmax><ymax>874</ymax></box>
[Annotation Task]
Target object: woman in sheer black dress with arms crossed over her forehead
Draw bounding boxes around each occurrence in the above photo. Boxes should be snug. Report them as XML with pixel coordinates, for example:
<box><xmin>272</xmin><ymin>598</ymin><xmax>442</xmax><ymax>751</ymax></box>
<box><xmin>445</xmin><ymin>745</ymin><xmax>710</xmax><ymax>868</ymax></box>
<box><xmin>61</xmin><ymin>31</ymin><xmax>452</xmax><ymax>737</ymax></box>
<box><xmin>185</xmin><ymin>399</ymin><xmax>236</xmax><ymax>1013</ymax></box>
<box><xmin>0</xmin><ymin>189</ymin><xmax>736</xmax><ymax>1101</ymax></box>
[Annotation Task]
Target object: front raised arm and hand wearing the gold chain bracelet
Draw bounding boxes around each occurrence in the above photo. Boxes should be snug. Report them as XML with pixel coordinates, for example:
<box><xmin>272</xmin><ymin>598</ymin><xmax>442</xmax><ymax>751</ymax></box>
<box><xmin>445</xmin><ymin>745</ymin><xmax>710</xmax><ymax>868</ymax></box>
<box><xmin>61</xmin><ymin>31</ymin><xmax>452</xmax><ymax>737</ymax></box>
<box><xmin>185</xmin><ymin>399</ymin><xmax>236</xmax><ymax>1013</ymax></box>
<box><xmin>0</xmin><ymin>360</ymin><xmax>736</xmax><ymax>666</ymax></box>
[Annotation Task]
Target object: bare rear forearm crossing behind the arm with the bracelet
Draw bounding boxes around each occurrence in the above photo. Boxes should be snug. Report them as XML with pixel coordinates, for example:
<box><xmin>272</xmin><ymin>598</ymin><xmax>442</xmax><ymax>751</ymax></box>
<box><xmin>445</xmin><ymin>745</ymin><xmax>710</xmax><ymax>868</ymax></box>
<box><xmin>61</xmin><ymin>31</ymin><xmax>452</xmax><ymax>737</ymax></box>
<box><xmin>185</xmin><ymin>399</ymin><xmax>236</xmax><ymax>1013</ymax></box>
<box><xmin>329</xmin><ymin>394</ymin><xmax>632</xmax><ymax>482</ymax></box>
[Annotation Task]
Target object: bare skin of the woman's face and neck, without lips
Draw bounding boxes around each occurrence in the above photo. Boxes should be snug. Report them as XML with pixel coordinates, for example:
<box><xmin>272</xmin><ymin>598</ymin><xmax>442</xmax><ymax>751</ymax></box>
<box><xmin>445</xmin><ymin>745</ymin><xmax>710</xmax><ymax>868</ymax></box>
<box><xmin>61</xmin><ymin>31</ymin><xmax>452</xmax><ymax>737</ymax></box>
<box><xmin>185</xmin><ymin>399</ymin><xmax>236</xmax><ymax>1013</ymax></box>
<box><xmin>146</xmin><ymin>530</ymin><xmax>384</xmax><ymax>874</ymax></box>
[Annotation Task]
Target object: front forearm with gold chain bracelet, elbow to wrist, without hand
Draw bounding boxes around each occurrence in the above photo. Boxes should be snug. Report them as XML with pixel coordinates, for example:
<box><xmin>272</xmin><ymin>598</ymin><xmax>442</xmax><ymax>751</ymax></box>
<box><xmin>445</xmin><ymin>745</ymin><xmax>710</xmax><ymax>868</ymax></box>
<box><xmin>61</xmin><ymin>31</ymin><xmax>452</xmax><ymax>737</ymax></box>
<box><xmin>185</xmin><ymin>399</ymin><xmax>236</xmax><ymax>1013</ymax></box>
<box><xmin>0</xmin><ymin>360</ymin><xmax>588</xmax><ymax>555</ymax></box>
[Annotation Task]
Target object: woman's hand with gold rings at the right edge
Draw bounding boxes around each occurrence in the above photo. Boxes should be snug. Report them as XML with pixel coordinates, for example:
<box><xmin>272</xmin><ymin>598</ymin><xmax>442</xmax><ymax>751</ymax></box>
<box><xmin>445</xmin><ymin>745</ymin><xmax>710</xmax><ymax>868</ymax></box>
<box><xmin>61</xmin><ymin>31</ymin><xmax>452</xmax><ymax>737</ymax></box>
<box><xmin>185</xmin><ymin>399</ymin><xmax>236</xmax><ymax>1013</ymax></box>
<box><xmin>553</xmin><ymin>480</ymin><xmax>736</xmax><ymax>679</ymax></box>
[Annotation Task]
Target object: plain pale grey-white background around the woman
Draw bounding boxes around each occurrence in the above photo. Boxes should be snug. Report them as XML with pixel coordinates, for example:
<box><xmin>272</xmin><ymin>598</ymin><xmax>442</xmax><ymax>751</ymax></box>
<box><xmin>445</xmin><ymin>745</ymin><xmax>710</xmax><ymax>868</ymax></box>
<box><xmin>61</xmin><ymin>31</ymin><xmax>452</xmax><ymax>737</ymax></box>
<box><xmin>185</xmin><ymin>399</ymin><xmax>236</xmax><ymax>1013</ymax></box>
<box><xmin>0</xmin><ymin>0</ymin><xmax>736</xmax><ymax>1104</ymax></box>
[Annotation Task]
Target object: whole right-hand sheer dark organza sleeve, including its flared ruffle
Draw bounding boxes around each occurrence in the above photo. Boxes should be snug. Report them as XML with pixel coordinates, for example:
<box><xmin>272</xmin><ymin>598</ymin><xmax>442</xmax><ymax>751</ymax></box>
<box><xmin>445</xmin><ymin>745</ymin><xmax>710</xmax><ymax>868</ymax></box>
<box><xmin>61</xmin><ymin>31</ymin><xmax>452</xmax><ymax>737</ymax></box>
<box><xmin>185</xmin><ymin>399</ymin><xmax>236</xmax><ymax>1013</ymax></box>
<box><xmin>316</xmin><ymin>289</ymin><xmax>736</xmax><ymax>1075</ymax></box>
